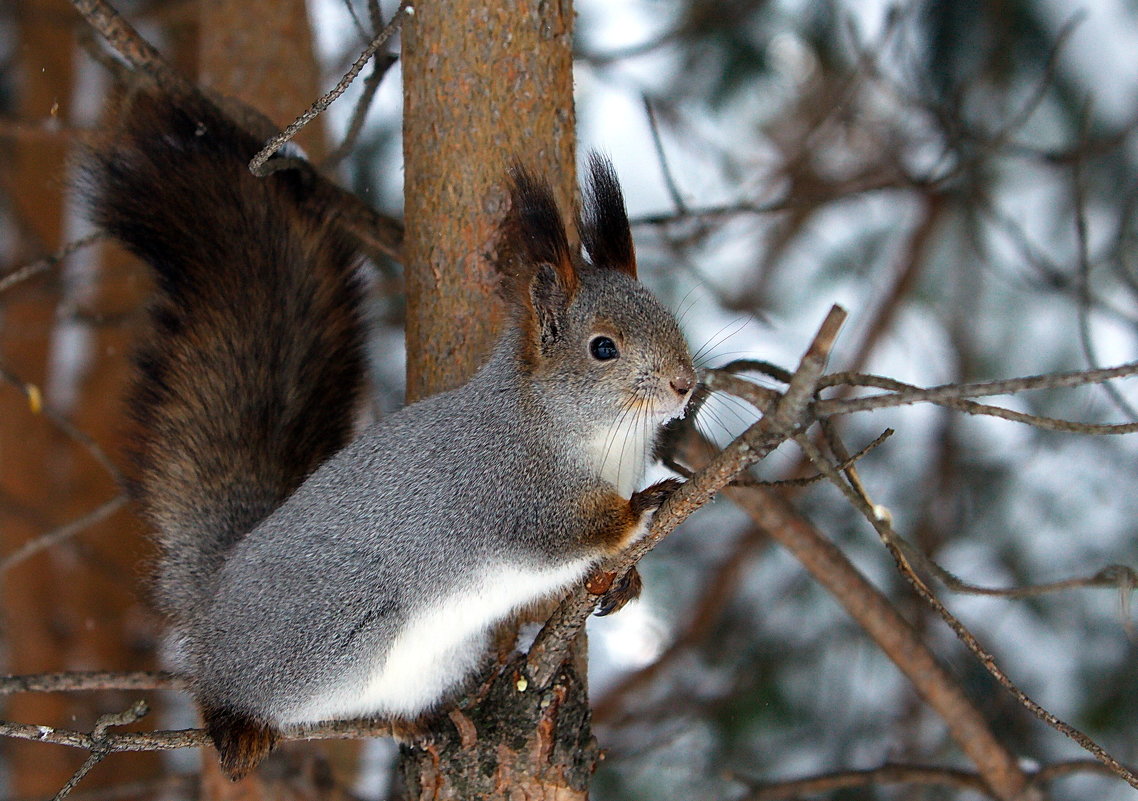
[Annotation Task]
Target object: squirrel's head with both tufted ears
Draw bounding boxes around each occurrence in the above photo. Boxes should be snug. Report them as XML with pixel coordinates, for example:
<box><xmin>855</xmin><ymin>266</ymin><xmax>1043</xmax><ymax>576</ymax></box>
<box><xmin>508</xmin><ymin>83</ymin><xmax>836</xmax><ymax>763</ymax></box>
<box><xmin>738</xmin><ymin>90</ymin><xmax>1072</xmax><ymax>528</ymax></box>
<box><xmin>502</xmin><ymin>154</ymin><xmax>695</xmax><ymax>428</ymax></box>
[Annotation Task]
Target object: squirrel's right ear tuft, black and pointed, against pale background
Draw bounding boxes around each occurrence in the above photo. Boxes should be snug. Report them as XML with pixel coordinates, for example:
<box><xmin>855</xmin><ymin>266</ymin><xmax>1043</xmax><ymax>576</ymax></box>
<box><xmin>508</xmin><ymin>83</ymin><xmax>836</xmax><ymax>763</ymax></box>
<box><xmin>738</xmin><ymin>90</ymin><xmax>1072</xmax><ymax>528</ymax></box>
<box><xmin>580</xmin><ymin>151</ymin><xmax>636</xmax><ymax>278</ymax></box>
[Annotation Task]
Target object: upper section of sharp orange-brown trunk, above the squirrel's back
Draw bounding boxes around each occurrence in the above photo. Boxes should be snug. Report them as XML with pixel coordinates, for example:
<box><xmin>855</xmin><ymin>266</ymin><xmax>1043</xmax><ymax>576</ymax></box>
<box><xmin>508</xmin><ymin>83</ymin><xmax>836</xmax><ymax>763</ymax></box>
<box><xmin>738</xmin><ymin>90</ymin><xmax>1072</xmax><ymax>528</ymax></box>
<box><xmin>403</xmin><ymin>0</ymin><xmax>574</xmax><ymax>401</ymax></box>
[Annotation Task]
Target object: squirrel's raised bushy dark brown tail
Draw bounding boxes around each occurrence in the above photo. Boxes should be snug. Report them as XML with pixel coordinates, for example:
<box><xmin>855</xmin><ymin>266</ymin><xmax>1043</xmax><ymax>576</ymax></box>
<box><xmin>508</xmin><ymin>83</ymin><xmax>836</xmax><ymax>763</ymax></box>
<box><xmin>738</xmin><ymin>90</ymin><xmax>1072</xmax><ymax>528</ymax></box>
<box><xmin>84</xmin><ymin>93</ymin><xmax>363</xmax><ymax>619</ymax></box>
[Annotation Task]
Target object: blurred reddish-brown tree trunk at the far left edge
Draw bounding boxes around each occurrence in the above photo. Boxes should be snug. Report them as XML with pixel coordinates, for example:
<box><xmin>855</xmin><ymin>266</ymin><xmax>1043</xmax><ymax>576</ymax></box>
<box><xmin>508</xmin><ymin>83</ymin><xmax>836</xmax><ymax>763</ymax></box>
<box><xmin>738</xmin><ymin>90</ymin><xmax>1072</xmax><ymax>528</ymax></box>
<box><xmin>0</xmin><ymin>0</ymin><xmax>158</xmax><ymax>798</ymax></box>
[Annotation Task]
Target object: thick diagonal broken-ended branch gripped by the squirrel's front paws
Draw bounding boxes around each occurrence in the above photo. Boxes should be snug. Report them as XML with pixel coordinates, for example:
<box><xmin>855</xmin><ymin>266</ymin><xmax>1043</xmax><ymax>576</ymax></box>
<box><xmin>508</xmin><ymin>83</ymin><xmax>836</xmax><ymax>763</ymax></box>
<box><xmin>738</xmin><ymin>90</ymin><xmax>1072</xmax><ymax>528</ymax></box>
<box><xmin>526</xmin><ymin>306</ymin><xmax>846</xmax><ymax>687</ymax></box>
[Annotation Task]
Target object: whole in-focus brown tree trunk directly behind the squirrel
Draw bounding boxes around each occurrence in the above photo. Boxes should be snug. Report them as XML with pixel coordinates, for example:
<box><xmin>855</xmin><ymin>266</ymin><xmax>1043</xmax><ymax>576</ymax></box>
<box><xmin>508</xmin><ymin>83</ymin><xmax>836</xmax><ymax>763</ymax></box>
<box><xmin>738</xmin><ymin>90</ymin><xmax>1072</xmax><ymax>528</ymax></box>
<box><xmin>401</xmin><ymin>0</ymin><xmax>597</xmax><ymax>801</ymax></box>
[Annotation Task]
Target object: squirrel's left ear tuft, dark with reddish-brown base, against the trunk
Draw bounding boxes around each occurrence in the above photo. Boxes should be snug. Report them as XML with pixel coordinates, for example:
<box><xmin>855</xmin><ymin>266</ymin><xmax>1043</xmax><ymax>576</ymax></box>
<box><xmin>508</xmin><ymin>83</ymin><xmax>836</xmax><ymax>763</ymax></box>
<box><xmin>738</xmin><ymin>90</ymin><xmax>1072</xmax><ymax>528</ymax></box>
<box><xmin>501</xmin><ymin>164</ymin><xmax>577</xmax><ymax>297</ymax></box>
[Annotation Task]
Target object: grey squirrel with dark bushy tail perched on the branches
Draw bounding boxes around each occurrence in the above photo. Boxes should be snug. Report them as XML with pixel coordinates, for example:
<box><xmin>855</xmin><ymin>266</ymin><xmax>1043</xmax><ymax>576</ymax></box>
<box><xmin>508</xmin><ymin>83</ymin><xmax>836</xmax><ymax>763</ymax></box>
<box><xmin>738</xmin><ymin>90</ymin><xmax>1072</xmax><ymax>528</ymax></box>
<box><xmin>86</xmin><ymin>92</ymin><xmax>695</xmax><ymax>779</ymax></box>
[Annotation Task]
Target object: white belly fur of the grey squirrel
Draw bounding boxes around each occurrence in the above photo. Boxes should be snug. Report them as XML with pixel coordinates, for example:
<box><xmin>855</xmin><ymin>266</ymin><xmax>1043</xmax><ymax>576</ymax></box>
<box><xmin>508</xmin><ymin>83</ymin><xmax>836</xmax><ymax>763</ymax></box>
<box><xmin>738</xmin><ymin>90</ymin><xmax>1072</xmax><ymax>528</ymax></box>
<box><xmin>279</xmin><ymin>559</ymin><xmax>593</xmax><ymax>725</ymax></box>
